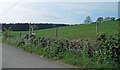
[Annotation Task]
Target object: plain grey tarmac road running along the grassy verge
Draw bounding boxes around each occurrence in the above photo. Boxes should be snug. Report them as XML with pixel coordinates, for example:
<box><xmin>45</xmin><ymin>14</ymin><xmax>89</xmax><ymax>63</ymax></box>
<box><xmin>2</xmin><ymin>44</ymin><xmax>71</xmax><ymax>68</ymax></box>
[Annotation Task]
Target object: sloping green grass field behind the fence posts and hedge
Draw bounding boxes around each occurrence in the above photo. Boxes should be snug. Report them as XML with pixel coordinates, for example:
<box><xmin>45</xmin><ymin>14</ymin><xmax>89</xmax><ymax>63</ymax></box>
<box><xmin>12</xmin><ymin>21</ymin><xmax>118</xmax><ymax>39</ymax></box>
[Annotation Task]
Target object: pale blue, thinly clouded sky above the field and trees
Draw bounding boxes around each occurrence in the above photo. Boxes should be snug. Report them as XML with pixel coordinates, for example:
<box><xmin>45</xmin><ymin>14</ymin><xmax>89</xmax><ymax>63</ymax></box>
<box><xmin>0</xmin><ymin>0</ymin><xmax>118</xmax><ymax>24</ymax></box>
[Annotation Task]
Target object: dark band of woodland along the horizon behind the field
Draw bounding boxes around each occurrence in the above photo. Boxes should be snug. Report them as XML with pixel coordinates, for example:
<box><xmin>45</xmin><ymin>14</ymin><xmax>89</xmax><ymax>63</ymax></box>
<box><xmin>2</xmin><ymin>23</ymin><xmax>68</xmax><ymax>31</ymax></box>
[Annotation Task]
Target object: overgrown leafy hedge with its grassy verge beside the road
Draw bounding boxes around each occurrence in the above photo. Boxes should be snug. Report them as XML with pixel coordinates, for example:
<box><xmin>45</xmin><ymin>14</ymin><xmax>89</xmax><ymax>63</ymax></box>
<box><xmin>2</xmin><ymin>33</ymin><xmax>120</xmax><ymax>68</ymax></box>
